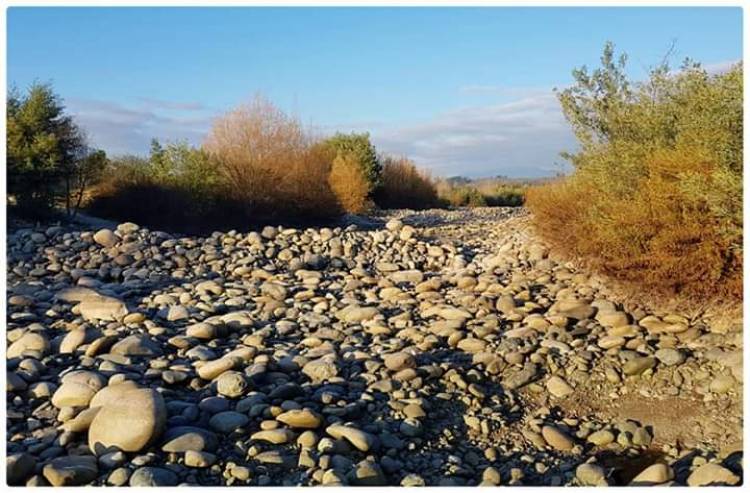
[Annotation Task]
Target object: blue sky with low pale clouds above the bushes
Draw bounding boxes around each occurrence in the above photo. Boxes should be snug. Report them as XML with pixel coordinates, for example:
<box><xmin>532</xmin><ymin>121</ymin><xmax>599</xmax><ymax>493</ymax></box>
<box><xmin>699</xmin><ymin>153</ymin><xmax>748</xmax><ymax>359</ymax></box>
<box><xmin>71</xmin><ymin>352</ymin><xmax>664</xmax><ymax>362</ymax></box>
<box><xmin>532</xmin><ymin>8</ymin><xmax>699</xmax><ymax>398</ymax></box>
<box><xmin>8</xmin><ymin>7</ymin><xmax>742</xmax><ymax>177</ymax></box>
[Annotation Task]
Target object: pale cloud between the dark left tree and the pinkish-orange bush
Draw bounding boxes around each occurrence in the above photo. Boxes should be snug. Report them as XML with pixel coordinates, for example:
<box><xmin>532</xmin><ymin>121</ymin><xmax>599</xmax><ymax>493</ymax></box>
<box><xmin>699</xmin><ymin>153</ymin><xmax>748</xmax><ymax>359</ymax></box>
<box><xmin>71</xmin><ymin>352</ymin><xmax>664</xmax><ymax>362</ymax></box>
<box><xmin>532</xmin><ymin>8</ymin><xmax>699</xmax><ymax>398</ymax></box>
<box><xmin>67</xmin><ymin>98</ymin><xmax>214</xmax><ymax>155</ymax></box>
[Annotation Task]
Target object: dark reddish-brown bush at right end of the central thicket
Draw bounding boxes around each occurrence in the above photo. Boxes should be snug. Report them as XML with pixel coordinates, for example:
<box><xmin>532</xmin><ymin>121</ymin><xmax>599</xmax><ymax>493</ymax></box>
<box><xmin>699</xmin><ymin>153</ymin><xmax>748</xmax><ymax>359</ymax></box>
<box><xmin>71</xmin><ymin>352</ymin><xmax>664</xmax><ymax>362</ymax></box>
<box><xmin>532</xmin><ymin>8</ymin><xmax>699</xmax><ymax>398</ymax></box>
<box><xmin>375</xmin><ymin>157</ymin><xmax>439</xmax><ymax>209</ymax></box>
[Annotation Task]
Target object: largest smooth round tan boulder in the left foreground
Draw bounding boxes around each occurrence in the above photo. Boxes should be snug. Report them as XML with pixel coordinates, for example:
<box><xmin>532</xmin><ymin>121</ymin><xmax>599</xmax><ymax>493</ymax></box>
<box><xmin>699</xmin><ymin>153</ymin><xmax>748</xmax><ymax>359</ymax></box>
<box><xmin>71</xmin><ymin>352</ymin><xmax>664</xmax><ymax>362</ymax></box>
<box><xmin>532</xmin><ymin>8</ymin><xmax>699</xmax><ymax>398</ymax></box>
<box><xmin>89</xmin><ymin>389</ymin><xmax>167</xmax><ymax>454</ymax></box>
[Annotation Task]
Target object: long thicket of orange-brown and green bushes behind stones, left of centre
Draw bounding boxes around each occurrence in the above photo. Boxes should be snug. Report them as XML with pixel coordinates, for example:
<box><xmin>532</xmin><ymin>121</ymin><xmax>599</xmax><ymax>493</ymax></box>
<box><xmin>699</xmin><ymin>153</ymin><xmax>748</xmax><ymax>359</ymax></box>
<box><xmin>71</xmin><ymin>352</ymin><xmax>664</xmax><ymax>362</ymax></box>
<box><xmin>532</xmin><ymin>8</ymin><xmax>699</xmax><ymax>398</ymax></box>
<box><xmin>90</xmin><ymin>97</ymin><xmax>444</xmax><ymax>231</ymax></box>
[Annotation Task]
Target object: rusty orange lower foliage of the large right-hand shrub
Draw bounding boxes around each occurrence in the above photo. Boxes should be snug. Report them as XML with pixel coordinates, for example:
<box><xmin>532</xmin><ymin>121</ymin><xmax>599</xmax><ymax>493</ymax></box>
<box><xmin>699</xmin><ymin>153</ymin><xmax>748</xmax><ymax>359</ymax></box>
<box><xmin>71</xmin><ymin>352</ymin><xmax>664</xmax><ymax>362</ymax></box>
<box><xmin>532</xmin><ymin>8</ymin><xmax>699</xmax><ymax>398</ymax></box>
<box><xmin>527</xmin><ymin>143</ymin><xmax>742</xmax><ymax>298</ymax></box>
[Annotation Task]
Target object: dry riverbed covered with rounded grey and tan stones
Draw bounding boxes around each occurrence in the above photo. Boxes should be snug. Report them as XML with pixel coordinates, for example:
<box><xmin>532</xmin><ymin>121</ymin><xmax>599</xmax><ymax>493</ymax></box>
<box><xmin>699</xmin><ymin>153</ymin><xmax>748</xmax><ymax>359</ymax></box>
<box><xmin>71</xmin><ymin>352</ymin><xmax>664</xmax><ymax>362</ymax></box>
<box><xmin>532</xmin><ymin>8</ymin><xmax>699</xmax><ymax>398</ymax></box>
<box><xmin>6</xmin><ymin>208</ymin><xmax>743</xmax><ymax>486</ymax></box>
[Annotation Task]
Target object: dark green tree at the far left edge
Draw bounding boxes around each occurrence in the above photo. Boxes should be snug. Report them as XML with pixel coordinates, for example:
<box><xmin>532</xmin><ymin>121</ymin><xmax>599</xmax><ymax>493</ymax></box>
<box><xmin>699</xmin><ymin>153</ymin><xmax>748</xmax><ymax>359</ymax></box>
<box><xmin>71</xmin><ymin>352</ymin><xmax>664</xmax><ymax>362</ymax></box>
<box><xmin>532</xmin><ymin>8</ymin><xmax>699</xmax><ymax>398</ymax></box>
<box><xmin>7</xmin><ymin>83</ymin><xmax>86</xmax><ymax>213</ymax></box>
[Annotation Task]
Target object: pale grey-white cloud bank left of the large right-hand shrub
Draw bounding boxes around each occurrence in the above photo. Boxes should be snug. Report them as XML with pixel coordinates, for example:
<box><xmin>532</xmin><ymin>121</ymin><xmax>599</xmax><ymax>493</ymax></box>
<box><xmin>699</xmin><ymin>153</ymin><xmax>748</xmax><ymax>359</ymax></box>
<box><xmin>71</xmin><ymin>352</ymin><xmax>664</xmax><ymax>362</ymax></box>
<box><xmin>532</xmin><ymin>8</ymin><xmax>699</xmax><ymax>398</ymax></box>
<box><xmin>373</xmin><ymin>91</ymin><xmax>576</xmax><ymax>177</ymax></box>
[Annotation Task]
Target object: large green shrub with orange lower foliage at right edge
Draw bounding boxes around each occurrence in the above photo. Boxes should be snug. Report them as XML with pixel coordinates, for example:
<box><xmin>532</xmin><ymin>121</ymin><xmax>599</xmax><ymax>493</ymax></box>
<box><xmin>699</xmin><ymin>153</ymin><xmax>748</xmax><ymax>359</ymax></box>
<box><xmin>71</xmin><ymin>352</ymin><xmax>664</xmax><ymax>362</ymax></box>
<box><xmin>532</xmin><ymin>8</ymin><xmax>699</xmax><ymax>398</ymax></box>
<box><xmin>527</xmin><ymin>45</ymin><xmax>742</xmax><ymax>298</ymax></box>
